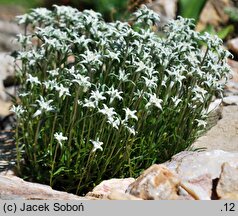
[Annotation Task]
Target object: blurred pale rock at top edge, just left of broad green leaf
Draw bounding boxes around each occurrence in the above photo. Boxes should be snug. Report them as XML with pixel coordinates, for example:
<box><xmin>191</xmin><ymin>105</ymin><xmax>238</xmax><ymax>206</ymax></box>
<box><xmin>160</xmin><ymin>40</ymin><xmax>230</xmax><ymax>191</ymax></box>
<box><xmin>147</xmin><ymin>0</ymin><xmax>178</xmax><ymax>24</ymax></box>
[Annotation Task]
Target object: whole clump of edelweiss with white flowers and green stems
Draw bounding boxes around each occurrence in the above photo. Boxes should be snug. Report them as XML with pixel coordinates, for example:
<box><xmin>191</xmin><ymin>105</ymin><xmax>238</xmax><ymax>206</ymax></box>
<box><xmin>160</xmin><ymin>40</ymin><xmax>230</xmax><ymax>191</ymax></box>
<box><xmin>12</xmin><ymin>6</ymin><xmax>229</xmax><ymax>194</ymax></box>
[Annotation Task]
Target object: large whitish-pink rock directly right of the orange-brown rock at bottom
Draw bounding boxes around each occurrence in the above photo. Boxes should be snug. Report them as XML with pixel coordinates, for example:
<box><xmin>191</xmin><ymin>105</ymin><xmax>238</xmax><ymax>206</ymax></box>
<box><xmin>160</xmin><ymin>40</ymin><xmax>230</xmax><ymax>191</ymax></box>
<box><xmin>164</xmin><ymin>150</ymin><xmax>238</xmax><ymax>200</ymax></box>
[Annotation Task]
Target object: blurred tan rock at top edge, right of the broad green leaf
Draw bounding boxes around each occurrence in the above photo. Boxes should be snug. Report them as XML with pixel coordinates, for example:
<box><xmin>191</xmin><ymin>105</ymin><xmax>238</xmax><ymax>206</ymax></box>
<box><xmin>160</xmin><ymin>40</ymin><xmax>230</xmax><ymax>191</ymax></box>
<box><xmin>196</xmin><ymin>0</ymin><xmax>231</xmax><ymax>31</ymax></box>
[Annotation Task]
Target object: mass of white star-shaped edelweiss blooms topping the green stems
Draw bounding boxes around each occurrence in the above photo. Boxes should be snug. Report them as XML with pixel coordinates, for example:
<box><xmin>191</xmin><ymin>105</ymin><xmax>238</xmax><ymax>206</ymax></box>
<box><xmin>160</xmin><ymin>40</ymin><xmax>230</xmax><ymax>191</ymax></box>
<box><xmin>15</xmin><ymin>6</ymin><xmax>229</xmax><ymax>154</ymax></box>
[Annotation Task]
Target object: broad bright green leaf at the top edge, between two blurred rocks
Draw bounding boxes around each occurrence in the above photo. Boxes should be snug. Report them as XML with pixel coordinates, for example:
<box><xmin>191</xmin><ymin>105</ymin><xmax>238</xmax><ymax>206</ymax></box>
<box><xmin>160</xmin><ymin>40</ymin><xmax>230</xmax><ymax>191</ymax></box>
<box><xmin>179</xmin><ymin>0</ymin><xmax>206</xmax><ymax>21</ymax></box>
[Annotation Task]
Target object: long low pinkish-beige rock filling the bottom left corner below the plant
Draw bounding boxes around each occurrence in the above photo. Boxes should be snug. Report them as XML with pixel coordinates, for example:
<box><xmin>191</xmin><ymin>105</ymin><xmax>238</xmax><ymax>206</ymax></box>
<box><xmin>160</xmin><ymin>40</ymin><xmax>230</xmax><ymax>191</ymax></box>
<box><xmin>0</xmin><ymin>173</ymin><xmax>86</xmax><ymax>200</ymax></box>
